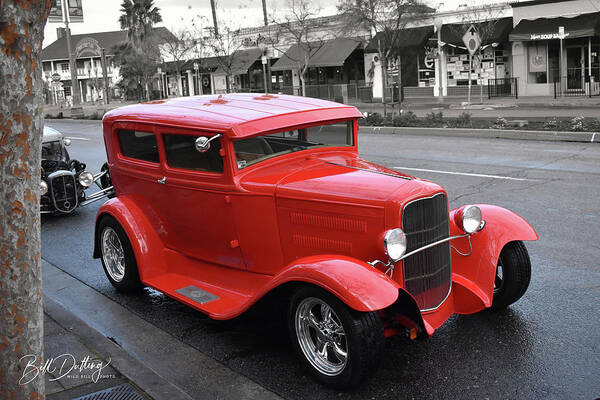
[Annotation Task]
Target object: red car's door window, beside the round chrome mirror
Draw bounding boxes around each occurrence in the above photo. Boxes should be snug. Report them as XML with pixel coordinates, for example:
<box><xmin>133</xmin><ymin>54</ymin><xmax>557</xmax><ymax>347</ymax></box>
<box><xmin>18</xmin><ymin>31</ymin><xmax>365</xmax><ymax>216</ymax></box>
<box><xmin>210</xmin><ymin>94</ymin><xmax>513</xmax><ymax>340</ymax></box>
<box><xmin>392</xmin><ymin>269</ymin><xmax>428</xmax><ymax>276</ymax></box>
<box><xmin>163</xmin><ymin>134</ymin><xmax>223</xmax><ymax>172</ymax></box>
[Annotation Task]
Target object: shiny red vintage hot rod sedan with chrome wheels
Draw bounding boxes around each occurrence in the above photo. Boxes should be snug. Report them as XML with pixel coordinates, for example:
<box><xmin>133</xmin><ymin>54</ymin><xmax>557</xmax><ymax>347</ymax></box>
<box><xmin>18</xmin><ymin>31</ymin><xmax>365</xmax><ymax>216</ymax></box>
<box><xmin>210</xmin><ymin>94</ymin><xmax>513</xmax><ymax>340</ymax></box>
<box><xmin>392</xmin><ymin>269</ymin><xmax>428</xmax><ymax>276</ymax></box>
<box><xmin>94</xmin><ymin>94</ymin><xmax>538</xmax><ymax>388</ymax></box>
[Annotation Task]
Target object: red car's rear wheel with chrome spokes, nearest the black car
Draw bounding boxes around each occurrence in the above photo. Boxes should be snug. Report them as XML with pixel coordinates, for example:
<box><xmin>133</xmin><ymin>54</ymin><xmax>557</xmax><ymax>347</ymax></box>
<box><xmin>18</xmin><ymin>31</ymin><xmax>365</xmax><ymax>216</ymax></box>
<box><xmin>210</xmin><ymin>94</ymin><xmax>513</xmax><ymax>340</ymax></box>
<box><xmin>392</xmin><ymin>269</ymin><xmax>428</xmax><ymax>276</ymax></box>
<box><xmin>98</xmin><ymin>216</ymin><xmax>142</xmax><ymax>293</ymax></box>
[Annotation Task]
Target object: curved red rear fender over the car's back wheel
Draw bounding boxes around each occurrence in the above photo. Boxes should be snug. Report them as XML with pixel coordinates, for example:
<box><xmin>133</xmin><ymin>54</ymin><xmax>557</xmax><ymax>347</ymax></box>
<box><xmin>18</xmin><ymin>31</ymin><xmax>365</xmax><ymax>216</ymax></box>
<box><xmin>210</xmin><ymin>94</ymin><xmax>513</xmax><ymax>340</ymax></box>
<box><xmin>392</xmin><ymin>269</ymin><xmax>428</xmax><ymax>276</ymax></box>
<box><xmin>94</xmin><ymin>196</ymin><xmax>165</xmax><ymax>282</ymax></box>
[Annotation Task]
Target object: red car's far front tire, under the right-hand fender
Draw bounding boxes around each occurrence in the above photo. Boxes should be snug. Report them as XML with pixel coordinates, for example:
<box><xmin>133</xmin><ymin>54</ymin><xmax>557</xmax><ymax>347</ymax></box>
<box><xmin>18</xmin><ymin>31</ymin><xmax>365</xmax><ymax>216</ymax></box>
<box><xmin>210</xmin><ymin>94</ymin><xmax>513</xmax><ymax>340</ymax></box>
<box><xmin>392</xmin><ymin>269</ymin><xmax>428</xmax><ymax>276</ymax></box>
<box><xmin>492</xmin><ymin>241</ymin><xmax>531</xmax><ymax>310</ymax></box>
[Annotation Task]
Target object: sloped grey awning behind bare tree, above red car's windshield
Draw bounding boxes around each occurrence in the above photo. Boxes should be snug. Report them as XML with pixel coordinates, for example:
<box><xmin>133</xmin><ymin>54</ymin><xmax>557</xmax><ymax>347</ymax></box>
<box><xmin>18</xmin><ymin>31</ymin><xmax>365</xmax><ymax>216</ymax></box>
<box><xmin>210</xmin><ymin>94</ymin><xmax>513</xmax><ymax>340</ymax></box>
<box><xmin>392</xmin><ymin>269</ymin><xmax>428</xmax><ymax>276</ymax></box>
<box><xmin>271</xmin><ymin>38</ymin><xmax>361</xmax><ymax>71</ymax></box>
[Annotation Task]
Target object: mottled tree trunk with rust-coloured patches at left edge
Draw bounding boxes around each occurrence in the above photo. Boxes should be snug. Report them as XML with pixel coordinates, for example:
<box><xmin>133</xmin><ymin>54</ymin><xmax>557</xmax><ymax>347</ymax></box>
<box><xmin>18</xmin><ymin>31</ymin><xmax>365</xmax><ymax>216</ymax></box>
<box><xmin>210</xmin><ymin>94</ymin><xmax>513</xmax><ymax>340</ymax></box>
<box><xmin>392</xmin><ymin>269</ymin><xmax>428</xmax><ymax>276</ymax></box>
<box><xmin>0</xmin><ymin>0</ymin><xmax>50</xmax><ymax>399</ymax></box>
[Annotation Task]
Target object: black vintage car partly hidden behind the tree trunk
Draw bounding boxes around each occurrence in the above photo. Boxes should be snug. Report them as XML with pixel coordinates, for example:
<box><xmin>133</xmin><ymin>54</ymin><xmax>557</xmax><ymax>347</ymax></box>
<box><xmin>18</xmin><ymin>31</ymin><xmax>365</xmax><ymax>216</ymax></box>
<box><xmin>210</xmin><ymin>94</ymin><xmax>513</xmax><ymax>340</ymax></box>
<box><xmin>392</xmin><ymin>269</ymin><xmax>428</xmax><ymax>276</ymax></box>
<box><xmin>40</xmin><ymin>126</ymin><xmax>112</xmax><ymax>215</ymax></box>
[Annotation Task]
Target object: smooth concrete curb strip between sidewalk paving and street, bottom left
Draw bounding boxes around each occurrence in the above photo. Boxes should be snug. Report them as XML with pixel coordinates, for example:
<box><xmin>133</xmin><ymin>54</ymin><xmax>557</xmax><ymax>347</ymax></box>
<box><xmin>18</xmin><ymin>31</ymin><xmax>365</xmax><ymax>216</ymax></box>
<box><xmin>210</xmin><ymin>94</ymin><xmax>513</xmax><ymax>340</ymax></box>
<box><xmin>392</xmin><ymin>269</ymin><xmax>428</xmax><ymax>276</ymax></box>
<box><xmin>42</xmin><ymin>258</ymin><xmax>281</xmax><ymax>400</ymax></box>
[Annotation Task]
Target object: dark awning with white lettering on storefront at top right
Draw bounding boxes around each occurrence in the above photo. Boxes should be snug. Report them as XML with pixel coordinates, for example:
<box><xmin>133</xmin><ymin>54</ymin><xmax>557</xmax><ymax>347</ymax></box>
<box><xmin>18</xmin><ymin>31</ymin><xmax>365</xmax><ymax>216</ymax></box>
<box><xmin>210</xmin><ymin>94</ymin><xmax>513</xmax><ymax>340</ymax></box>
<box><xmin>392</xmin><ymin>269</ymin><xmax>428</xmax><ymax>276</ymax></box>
<box><xmin>510</xmin><ymin>13</ymin><xmax>600</xmax><ymax>42</ymax></box>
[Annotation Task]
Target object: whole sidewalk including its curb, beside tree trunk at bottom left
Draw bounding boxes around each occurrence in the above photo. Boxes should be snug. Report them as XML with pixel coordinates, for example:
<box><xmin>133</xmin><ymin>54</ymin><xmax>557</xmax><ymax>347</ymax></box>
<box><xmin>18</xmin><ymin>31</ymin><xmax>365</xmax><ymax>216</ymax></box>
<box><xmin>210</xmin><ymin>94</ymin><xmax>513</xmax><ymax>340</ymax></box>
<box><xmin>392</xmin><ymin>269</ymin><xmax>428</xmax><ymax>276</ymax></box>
<box><xmin>42</xmin><ymin>260</ymin><xmax>280</xmax><ymax>400</ymax></box>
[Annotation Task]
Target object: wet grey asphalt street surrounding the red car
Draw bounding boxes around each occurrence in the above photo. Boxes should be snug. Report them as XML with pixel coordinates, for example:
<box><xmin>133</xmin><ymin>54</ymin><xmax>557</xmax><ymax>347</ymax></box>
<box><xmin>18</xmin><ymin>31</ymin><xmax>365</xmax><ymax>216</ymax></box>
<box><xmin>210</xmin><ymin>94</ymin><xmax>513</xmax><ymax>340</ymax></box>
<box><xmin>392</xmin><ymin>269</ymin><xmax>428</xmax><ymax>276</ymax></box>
<box><xmin>42</xmin><ymin>121</ymin><xmax>600</xmax><ymax>399</ymax></box>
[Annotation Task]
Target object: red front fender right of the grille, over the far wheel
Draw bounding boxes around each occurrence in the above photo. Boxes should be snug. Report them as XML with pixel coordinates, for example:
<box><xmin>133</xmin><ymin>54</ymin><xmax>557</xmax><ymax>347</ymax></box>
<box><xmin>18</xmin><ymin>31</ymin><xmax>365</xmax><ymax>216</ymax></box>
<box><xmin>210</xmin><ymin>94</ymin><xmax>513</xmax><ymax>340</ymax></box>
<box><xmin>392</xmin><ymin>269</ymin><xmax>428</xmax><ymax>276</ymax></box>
<box><xmin>450</xmin><ymin>204</ymin><xmax>539</xmax><ymax>314</ymax></box>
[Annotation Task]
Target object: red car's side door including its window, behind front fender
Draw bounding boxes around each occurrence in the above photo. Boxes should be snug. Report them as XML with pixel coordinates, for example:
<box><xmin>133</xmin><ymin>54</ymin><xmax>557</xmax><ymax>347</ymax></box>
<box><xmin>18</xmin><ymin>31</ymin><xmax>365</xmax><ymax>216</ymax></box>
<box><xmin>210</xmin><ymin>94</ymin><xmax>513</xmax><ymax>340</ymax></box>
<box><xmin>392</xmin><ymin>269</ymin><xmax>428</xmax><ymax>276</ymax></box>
<box><xmin>157</xmin><ymin>128</ymin><xmax>245</xmax><ymax>268</ymax></box>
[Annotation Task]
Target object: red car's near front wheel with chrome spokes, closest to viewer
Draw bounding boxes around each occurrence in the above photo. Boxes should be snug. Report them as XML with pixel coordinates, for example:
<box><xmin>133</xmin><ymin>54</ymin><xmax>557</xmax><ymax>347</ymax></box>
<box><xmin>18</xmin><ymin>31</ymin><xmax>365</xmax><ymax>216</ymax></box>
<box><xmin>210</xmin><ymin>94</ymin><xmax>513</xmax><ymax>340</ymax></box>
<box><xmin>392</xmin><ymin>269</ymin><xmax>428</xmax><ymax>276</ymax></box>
<box><xmin>288</xmin><ymin>286</ymin><xmax>384</xmax><ymax>389</ymax></box>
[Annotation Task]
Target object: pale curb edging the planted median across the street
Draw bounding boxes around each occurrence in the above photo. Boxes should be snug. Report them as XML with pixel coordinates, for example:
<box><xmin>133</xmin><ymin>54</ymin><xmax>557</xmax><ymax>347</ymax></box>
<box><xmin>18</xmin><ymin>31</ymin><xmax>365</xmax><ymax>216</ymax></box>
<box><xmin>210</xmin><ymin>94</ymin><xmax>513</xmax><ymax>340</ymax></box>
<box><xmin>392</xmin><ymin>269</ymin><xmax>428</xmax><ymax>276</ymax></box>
<box><xmin>359</xmin><ymin>126</ymin><xmax>600</xmax><ymax>143</ymax></box>
